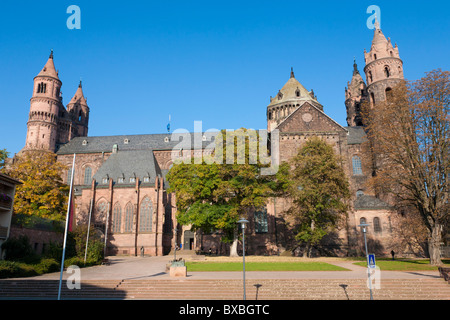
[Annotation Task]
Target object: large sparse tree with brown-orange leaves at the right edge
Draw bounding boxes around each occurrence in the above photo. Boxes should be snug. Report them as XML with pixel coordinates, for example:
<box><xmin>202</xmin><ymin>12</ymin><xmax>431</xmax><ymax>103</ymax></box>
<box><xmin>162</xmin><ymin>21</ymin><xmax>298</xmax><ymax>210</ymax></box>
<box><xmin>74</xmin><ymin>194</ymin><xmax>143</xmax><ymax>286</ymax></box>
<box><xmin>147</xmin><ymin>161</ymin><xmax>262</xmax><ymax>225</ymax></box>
<box><xmin>363</xmin><ymin>69</ymin><xmax>450</xmax><ymax>265</ymax></box>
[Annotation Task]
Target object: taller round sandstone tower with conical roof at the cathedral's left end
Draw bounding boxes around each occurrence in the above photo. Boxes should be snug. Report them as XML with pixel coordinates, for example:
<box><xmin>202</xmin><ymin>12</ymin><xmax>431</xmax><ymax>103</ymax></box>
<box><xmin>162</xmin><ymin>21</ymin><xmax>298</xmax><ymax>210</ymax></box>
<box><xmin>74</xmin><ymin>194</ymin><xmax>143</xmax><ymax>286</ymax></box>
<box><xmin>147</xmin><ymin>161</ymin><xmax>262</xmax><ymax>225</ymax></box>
<box><xmin>24</xmin><ymin>50</ymin><xmax>62</xmax><ymax>152</ymax></box>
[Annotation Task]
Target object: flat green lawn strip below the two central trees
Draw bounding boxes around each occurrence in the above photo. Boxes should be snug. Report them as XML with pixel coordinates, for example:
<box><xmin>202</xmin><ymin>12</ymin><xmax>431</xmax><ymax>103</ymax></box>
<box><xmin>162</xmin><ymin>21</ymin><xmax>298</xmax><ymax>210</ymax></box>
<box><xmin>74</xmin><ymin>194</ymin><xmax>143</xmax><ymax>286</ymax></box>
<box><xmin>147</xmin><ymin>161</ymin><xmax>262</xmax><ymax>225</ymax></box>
<box><xmin>186</xmin><ymin>261</ymin><xmax>348</xmax><ymax>271</ymax></box>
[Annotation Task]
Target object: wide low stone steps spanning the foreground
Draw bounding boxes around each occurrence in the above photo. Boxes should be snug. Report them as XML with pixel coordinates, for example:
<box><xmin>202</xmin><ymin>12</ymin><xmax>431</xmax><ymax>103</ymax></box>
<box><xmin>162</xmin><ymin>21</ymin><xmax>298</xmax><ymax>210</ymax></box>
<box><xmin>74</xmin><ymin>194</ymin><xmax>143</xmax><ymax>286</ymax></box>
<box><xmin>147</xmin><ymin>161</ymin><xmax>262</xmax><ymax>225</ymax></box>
<box><xmin>0</xmin><ymin>278</ymin><xmax>450</xmax><ymax>300</ymax></box>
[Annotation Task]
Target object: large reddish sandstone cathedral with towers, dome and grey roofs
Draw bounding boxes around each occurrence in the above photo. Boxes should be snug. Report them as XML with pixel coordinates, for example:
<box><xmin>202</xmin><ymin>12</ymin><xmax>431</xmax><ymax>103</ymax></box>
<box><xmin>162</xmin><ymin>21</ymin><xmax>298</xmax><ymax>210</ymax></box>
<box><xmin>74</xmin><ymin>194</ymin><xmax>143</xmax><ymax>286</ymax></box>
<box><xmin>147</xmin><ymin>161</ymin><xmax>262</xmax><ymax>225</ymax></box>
<box><xmin>23</xmin><ymin>26</ymin><xmax>403</xmax><ymax>256</ymax></box>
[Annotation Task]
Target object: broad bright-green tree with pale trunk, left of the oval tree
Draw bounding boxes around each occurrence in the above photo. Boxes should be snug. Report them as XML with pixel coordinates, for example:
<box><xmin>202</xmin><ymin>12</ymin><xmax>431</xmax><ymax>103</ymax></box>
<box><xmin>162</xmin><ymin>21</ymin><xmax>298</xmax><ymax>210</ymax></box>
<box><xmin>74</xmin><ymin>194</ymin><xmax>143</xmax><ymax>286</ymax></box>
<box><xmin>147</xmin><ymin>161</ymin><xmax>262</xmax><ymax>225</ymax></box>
<box><xmin>167</xmin><ymin>129</ymin><xmax>280</xmax><ymax>256</ymax></box>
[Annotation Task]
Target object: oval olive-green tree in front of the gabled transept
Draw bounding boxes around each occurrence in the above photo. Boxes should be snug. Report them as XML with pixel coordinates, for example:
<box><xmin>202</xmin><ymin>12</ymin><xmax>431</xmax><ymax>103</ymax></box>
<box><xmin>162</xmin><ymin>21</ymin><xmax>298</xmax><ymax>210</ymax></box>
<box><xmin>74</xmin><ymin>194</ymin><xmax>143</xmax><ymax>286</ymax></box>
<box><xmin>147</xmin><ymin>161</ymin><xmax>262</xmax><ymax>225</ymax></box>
<box><xmin>279</xmin><ymin>137</ymin><xmax>350</xmax><ymax>257</ymax></box>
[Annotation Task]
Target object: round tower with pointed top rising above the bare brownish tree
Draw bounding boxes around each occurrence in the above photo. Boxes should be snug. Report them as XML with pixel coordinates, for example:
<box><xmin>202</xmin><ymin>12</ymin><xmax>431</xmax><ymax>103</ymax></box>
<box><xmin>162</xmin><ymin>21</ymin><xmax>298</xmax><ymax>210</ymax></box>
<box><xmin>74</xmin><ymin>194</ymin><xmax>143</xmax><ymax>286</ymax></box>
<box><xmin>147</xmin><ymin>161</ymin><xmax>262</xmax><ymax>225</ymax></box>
<box><xmin>364</xmin><ymin>22</ymin><xmax>404</xmax><ymax>106</ymax></box>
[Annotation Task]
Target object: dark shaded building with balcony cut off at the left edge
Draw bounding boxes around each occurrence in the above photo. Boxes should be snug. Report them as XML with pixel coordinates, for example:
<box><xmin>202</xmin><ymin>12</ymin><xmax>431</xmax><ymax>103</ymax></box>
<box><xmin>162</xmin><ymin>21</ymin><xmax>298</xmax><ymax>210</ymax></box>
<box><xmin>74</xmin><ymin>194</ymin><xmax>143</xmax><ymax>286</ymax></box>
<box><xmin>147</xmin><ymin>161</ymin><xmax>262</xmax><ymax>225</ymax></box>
<box><xmin>0</xmin><ymin>173</ymin><xmax>22</xmax><ymax>259</ymax></box>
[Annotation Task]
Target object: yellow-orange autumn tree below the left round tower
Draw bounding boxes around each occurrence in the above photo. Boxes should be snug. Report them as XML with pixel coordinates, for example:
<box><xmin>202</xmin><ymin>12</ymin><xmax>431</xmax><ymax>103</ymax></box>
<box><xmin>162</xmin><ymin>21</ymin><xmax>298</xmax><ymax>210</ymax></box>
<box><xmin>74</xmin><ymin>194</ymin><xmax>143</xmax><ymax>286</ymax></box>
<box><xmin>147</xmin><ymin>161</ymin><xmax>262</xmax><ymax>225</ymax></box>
<box><xmin>6</xmin><ymin>151</ymin><xmax>69</xmax><ymax>221</ymax></box>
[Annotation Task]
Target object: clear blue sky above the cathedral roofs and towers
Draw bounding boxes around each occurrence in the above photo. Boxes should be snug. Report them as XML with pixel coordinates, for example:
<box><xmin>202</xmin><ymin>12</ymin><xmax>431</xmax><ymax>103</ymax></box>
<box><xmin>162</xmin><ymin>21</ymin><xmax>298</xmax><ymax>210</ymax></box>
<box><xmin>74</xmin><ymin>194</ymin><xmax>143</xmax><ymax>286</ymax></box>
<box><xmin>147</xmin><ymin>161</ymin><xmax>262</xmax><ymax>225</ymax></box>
<box><xmin>0</xmin><ymin>0</ymin><xmax>450</xmax><ymax>156</ymax></box>
